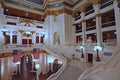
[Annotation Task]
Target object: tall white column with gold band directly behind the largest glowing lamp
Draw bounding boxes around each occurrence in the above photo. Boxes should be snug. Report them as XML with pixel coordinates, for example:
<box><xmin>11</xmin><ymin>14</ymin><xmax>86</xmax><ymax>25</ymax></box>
<box><xmin>94</xmin><ymin>4</ymin><xmax>103</xmax><ymax>46</ymax></box>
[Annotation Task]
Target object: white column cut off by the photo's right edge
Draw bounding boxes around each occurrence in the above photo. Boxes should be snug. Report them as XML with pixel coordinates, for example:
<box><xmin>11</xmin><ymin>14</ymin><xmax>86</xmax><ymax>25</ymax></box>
<box><xmin>114</xmin><ymin>0</ymin><xmax>120</xmax><ymax>45</ymax></box>
